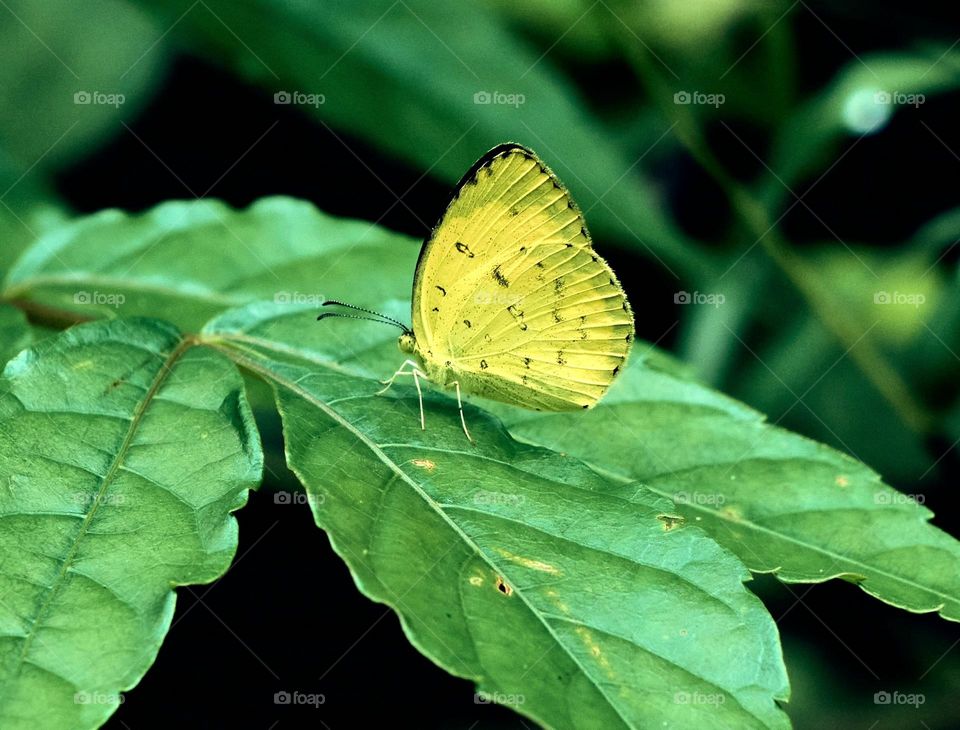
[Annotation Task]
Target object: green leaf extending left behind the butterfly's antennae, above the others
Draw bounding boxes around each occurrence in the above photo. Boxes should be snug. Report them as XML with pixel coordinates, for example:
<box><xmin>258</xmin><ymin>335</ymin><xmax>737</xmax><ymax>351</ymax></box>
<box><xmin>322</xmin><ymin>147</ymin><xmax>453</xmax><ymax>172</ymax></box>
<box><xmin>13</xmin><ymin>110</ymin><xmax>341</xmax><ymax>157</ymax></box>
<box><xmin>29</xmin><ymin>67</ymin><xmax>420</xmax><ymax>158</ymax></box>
<box><xmin>2</xmin><ymin>197</ymin><xmax>417</xmax><ymax>331</ymax></box>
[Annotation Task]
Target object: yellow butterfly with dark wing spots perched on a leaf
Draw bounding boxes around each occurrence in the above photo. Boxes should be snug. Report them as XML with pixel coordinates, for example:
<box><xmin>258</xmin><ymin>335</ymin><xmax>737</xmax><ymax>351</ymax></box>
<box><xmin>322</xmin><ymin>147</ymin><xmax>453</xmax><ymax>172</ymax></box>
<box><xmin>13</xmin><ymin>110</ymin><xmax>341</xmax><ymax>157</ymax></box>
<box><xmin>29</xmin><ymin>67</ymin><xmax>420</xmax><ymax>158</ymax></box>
<box><xmin>318</xmin><ymin>143</ymin><xmax>634</xmax><ymax>441</ymax></box>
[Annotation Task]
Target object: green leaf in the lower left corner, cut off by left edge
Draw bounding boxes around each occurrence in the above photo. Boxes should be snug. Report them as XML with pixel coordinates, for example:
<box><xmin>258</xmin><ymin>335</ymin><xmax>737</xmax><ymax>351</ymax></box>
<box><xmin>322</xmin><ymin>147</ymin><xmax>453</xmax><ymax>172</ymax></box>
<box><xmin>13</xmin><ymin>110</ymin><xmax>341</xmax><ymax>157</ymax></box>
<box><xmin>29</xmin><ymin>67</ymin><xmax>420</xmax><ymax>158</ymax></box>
<box><xmin>0</xmin><ymin>320</ymin><xmax>262</xmax><ymax>730</ymax></box>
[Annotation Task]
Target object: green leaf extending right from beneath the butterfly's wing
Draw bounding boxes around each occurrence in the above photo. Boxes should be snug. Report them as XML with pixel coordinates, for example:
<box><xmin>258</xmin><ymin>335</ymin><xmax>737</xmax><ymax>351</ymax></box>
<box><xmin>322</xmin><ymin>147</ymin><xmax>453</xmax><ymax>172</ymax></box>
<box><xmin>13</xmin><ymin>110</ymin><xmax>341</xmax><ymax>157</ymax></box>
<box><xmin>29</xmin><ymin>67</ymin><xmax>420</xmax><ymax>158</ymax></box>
<box><xmin>492</xmin><ymin>346</ymin><xmax>960</xmax><ymax>621</ymax></box>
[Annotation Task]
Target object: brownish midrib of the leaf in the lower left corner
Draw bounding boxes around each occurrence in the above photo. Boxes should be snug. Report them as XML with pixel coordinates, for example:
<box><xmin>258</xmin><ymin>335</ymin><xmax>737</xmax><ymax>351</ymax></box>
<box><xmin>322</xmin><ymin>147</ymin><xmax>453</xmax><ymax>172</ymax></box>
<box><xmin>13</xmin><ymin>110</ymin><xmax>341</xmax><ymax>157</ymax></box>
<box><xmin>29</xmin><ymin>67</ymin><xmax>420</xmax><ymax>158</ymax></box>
<box><xmin>8</xmin><ymin>338</ymin><xmax>194</xmax><ymax>686</ymax></box>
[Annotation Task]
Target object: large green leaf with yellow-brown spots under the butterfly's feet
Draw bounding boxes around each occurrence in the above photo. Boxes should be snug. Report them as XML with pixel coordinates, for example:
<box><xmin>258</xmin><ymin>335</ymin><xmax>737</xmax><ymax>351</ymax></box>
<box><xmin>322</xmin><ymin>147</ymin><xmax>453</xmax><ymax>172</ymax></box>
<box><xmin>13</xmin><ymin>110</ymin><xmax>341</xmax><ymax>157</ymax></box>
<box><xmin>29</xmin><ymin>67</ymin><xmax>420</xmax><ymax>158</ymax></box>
<box><xmin>202</xmin><ymin>303</ymin><xmax>787</xmax><ymax>728</ymax></box>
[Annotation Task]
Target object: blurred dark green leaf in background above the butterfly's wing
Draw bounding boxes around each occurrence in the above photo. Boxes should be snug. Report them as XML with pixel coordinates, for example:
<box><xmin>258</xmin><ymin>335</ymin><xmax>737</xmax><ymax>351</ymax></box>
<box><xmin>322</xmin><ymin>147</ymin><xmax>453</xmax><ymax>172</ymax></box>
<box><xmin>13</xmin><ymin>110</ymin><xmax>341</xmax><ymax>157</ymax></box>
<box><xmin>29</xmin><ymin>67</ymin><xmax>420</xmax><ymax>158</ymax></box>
<box><xmin>129</xmin><ymin>0</ymin><xmax>712</xmax><ymax>277</ymax></box>
